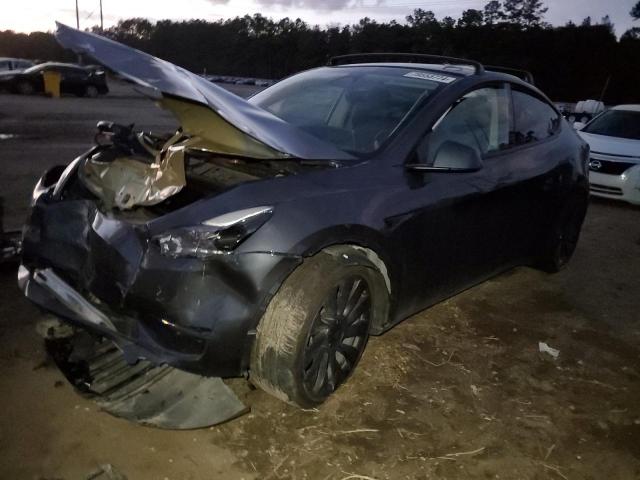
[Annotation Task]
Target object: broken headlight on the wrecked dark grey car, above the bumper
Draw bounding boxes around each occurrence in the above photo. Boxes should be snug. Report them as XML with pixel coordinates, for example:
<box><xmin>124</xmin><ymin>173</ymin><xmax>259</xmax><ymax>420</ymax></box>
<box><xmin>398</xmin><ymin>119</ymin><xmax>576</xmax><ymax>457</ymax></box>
<box><xmin>154</xmin><ymin>207</ymin><xmax>273</xmax><ymax>258</ymax></box>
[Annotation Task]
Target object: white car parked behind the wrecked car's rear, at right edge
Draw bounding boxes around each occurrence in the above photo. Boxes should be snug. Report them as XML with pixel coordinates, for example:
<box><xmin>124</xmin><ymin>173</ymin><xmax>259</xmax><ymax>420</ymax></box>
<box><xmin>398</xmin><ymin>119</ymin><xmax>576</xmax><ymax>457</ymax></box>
<box><xmin>574</xmin><ymin>105</ymin><xmax>640</xmax><ymax>205</ymax></box>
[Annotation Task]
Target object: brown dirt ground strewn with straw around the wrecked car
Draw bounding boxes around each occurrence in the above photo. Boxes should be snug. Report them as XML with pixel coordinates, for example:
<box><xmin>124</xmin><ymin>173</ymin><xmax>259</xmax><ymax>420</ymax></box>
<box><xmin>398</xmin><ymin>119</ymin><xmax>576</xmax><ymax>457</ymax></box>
<box><xmin>0</xmin><ymin>84</ymin><xmax>640</xmax><ymax>480</ymax></box>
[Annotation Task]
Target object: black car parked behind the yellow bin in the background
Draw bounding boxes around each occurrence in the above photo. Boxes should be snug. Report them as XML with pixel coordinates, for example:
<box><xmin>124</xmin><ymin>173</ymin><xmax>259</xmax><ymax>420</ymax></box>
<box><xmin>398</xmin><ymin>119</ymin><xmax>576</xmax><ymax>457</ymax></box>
<box><xmin>0</xmin><ymin>62</ymin><xmax>109</xmax><ymax>98</ymax></box>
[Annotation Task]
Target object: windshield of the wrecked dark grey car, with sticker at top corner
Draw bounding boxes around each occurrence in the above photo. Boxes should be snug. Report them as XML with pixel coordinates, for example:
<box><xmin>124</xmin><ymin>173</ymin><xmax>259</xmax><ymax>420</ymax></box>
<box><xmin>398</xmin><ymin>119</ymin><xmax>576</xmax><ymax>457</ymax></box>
<box><xmin>249</xmin><ymin>66</ymin><xmax>455</xmax><ymax>155</ymax></box>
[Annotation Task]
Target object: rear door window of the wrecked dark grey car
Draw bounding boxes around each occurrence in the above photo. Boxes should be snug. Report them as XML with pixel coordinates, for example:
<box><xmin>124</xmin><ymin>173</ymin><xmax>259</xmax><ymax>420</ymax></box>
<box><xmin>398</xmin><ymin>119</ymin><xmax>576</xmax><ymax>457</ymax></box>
<box><xmin>509</xmin><ymin>89</ymin><xmax>560</xmax><ymax>146</ymax></box>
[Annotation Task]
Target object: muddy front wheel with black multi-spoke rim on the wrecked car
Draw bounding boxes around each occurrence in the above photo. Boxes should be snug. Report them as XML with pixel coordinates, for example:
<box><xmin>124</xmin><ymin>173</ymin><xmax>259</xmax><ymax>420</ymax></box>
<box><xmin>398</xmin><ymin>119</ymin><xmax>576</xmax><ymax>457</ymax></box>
<box><xmin>249</xmin><ymin>252</ymin><xmax>386</xmax><ymax>408</ymax></box>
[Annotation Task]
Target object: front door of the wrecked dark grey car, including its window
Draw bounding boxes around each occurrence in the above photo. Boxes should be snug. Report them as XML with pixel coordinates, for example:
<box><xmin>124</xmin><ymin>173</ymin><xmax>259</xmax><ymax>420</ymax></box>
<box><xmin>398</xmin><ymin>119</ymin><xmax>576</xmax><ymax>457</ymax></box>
<box><xmin>396</xmin><ymin>84</ymin><xmax>514</xmax><ymax>315</ymax></box>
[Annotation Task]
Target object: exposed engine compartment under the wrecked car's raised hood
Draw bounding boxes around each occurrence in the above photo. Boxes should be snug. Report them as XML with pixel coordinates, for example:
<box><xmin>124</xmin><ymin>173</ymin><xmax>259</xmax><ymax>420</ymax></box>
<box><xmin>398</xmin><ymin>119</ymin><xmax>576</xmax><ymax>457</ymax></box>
<box><xmin>63</xmin><ymin>121</ymin><xmax>337</xmax><ymax>219</ymax></box>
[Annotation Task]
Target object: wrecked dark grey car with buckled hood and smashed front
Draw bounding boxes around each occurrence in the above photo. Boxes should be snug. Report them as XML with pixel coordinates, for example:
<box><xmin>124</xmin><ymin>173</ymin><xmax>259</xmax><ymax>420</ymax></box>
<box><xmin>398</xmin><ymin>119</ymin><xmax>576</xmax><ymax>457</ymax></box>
<box><xmin>19</xmin><ymin>26</ymin><xmax>588</xmax><ymax>420</ymax></box>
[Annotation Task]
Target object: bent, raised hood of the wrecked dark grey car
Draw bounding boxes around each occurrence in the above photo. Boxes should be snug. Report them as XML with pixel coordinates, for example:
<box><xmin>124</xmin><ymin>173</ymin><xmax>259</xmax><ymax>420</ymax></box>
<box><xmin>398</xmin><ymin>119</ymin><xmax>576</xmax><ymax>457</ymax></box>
<box><xmin>56</xmin><ymin>22</ymin><xmax>354</xmax><ymax>161</ymax></box>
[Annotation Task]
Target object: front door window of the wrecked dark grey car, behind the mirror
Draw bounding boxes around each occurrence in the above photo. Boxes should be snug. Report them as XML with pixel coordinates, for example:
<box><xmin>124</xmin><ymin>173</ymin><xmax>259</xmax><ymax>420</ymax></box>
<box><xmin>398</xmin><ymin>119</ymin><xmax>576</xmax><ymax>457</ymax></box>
<box><xmin>419</xmin><ymin>86</ymin><xmax>509</xmax><ymax>165</ymax></box>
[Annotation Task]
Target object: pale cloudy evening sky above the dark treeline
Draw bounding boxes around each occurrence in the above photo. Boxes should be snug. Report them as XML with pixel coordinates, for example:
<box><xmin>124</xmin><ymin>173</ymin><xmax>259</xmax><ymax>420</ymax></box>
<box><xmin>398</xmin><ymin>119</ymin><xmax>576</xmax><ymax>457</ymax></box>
<box><xmin>5</xmin><ymin>0</ymin><xmax>640</xmax><ymax>35</ymax></box>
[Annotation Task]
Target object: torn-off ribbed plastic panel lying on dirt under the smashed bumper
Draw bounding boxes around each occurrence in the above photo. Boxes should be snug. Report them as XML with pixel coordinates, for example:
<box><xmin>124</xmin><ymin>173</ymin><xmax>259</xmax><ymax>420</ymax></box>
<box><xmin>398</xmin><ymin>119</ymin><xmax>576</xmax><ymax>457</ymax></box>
<box><xmin>44</xmin><ymin>323</ymin><xmax>248</xmax><ymax>430</ymax></box>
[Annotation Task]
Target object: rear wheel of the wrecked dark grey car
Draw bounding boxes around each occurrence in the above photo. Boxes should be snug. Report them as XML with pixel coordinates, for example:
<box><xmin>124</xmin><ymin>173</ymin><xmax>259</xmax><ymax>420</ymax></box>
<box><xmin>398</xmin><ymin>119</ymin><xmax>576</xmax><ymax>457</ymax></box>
<box><xmin>538</xmin><ymin>195</ymin><xmax>588</xmax><ymax>273</ymax></box>
